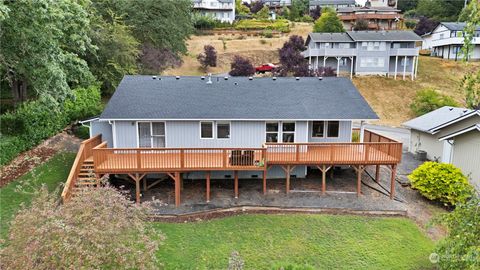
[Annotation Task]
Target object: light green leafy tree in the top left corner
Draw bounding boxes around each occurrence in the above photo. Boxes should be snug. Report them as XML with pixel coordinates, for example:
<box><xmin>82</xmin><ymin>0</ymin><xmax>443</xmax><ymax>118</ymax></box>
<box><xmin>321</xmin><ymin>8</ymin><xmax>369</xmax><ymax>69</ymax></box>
<box><xmin>0</xmin><ymin>0</ymin><xmax>93</xmax><ymax>103</ymax></box>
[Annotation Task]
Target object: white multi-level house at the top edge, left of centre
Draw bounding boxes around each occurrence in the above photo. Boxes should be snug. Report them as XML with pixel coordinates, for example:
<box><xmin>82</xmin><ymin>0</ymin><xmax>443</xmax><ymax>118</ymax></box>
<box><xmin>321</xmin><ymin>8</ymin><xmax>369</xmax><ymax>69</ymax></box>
<box><xmin>193</xmin><ymin>0</ymin><xmax>235</xmax><ymax>23</ymax></box>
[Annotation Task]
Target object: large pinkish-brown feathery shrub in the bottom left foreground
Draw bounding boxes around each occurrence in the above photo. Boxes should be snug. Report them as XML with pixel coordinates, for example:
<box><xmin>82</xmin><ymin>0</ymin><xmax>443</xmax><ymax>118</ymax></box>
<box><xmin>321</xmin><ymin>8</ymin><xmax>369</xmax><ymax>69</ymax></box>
<box><xmin>0</xmin><ymin>186</ymin><xmax>164</xmax><ymax>269</ymax></box>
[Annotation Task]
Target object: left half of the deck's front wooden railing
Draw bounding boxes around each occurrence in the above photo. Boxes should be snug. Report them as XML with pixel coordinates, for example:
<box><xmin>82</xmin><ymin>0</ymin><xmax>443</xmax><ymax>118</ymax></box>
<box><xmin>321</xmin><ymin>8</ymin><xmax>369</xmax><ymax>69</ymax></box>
<box><xmin>93</xmin><ymin>148</ymin><xmax>266</xmax><ymax>173</ymax></box>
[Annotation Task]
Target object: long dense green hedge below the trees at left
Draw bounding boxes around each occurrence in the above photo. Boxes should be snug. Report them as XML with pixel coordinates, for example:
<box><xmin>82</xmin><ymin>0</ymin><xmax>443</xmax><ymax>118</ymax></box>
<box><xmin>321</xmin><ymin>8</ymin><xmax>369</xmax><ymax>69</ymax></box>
<box><xmin>0</xmin><ymin>86</ymin><xmax>101</xmax><ymax>165</ymax></box>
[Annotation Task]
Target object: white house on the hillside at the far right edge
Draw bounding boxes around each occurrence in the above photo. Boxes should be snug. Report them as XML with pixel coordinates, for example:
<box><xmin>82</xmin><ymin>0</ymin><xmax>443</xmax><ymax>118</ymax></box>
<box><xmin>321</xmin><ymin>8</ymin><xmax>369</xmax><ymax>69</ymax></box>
<box><xmin>422</xmin><ymin>22</ymin><xmax>480</xmax><ymax>61</ymax></box>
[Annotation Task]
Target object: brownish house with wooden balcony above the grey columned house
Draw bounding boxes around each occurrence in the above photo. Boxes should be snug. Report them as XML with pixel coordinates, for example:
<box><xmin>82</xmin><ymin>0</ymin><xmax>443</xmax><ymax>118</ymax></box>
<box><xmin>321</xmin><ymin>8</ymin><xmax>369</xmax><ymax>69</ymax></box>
<box><xmin>337</xmin><ymin>6</ymin><xmax>403</xmax><ymax>30</ymax></box>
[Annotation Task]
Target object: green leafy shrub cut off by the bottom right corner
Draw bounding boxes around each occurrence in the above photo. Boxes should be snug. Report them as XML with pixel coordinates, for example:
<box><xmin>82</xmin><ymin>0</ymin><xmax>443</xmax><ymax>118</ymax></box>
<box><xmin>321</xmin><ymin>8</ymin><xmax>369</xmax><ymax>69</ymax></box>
<box><xmin>435</xmin><ymin>197</ymin><xmax>480</xmax><ymax>269</ymax></box>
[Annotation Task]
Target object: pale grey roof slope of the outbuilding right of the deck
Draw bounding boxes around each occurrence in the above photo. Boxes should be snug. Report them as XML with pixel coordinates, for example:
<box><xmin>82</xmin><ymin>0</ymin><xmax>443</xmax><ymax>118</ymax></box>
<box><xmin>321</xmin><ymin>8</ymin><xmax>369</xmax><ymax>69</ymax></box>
<box><xmin>402</xmin><ymin>106</ymin><xmax>474</xmax><ymax>134</ymax></box>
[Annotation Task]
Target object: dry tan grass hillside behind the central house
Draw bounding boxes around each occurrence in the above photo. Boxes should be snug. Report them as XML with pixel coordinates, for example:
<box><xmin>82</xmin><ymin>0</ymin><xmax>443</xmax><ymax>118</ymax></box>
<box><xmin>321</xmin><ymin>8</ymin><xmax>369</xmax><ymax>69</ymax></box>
<box><xmin>164</xmin><ymin>23</ymin><xmax>480</xmax><ymax>126</ymax></box>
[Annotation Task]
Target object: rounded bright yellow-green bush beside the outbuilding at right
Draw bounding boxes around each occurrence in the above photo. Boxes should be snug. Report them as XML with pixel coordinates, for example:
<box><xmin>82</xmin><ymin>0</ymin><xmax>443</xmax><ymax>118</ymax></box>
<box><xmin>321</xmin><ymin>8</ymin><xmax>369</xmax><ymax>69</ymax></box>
<box><xmin>408</xmin><ymin>161</ymin><xmax>473</xmax><ymax>205</ymax></box>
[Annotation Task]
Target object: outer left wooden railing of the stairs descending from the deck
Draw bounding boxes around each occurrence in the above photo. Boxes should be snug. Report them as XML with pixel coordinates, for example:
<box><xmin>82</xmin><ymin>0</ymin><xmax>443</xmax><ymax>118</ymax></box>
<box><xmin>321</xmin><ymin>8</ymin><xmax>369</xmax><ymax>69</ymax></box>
<box><xmin>62</xmin><ymin>134</ymin><xmax>102</xmax><ymax>202</ymax></box>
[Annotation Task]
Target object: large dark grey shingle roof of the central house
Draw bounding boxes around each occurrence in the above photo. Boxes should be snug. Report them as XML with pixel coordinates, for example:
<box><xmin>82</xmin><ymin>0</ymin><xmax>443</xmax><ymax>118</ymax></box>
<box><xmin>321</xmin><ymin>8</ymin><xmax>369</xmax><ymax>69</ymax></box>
<box><xmin>100</xmin><ymin>76</ymin><xmax>378</xmax><ymax>120</ymax></box>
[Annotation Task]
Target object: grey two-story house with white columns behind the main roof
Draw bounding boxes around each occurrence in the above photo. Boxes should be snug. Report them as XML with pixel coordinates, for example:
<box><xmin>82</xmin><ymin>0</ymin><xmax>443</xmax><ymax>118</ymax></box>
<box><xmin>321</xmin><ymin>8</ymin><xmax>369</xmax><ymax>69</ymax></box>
<box><xmin>303</xmin><ymin>31</ymin><xmax>422</xmax><ymax>80</ymax></box>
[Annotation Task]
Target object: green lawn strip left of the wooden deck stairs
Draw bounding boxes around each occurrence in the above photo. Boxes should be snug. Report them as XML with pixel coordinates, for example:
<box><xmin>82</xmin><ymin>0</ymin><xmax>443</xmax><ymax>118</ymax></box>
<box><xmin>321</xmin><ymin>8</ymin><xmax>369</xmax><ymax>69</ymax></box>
<box><xmin>0</xmin><ymin>153</ymin><xmax>75</xmax><ymax>239</ymax></box>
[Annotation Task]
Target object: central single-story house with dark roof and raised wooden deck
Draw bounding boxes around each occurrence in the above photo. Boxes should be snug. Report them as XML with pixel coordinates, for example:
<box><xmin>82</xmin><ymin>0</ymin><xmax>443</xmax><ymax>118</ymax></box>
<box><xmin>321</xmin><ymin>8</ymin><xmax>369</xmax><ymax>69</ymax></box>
<box><xmin>62</xmin><ymin>76</ymin><xmax>402</xmax><ymax>206</ymax></box>
